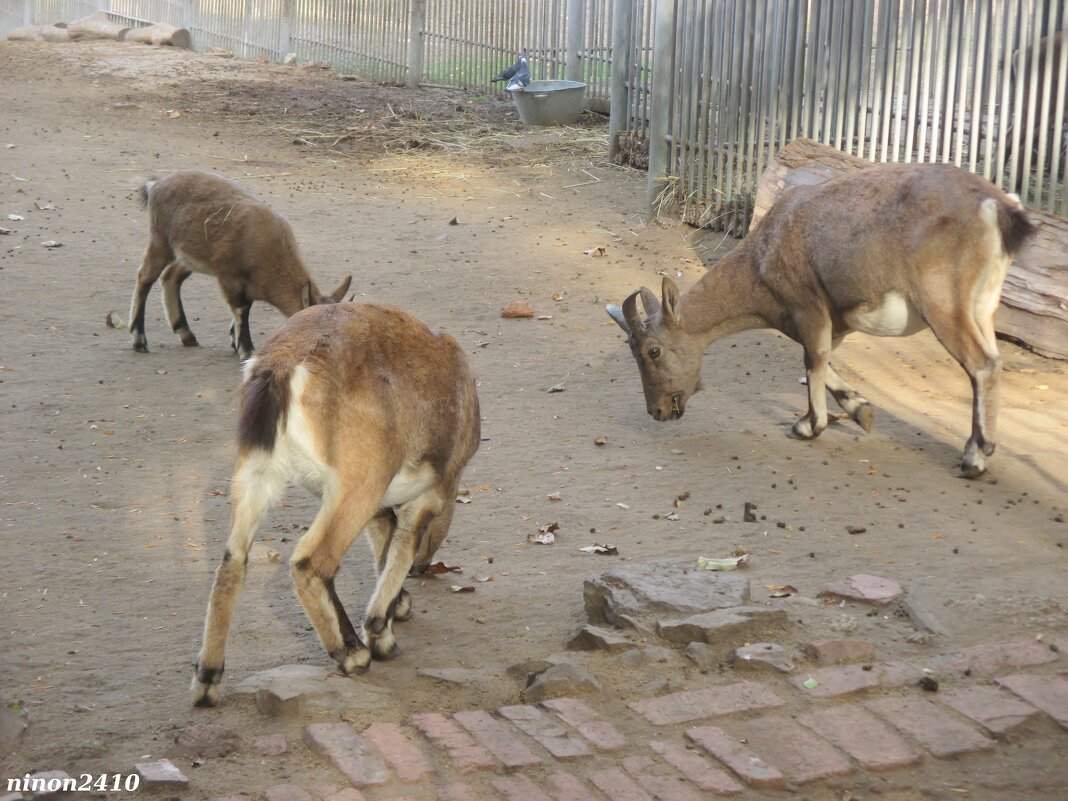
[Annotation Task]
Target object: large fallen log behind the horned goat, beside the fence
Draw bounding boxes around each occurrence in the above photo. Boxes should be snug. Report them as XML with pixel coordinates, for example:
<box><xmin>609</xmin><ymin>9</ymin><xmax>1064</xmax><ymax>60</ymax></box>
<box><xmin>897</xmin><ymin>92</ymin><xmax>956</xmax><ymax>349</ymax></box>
<box><xmin>750</xmin><ymin>139</ymin><xmax>1068</xmax><ymax>359</ymax></box>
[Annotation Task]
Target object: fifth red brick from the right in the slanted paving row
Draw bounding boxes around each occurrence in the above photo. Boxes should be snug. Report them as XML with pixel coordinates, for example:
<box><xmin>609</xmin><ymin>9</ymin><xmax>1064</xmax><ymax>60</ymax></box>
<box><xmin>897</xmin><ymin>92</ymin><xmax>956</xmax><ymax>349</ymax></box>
<box><xmin>735</xmin><ymin>717</ymin><xmax>853</xmax><ymax>784</ymax></box>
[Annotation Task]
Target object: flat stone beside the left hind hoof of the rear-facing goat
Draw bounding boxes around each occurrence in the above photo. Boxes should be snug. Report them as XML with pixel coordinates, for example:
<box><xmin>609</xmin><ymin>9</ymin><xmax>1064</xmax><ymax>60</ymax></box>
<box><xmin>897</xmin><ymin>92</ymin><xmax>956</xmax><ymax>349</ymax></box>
<box><xmin>233</xmin><ymin>664</ymin><xmax>392</xmax><ymax>717</ymax></box>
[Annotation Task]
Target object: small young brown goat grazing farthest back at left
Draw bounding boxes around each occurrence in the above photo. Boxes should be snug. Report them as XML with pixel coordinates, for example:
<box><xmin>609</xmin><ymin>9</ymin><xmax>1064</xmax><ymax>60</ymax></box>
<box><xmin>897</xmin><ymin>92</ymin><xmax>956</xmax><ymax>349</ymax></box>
<box><xmin>130</xmin><ymin>170</ymin><xmax>352</xmax><ymax>359</ymax></box>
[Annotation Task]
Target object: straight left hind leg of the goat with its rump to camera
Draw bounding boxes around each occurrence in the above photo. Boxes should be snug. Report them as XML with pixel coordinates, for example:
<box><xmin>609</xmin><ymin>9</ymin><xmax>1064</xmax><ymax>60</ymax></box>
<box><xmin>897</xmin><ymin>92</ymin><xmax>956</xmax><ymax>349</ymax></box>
<box><xmin>192</xmin><ymin>453</ymin><xmax>285</xmax><ymax>706</ymax></box>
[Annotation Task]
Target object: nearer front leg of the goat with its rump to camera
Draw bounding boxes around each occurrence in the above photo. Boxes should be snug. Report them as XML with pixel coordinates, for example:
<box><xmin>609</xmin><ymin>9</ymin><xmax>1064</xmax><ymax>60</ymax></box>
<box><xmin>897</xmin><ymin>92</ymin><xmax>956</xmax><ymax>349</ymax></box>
<box><xmin>363</xmin><ymin>490</ymin><xmax>451</xmax><ymax>659</ymax></box>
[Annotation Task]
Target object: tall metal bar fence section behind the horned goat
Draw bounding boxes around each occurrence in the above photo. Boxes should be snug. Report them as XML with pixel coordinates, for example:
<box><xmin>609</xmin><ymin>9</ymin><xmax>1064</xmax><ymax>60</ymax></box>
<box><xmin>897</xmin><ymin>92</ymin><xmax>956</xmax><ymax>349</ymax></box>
<box><xmin>640</xmin><ymin>0</ymin><xmax>1068</xmax><ymax>234</ymax></box>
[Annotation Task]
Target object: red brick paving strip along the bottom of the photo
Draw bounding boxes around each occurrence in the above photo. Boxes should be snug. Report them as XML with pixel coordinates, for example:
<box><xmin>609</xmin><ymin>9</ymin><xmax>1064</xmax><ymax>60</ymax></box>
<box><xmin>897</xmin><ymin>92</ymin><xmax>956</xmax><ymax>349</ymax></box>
<box><xmin>212</xmin><ymin>639</ymin><xmax>1068</xmax><ymax>801</ymax></box>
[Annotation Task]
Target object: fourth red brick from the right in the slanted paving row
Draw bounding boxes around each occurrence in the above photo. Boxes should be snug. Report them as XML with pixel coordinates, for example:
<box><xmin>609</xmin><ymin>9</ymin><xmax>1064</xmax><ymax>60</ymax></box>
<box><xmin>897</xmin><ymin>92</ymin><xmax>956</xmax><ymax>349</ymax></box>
<box><xmin>798</xmin><ymin>704</ymin><xmax>921</xmax><ymax>771</ymax></box>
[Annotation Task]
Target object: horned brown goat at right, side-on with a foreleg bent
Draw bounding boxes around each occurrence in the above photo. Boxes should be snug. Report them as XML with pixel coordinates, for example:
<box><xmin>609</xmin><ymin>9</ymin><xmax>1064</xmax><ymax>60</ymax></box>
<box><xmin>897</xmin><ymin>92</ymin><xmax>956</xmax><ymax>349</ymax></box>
<box><xmin>608</xmin><ymin>164</ymin><xmax>1035</xmax><ymax>477</ymax></box>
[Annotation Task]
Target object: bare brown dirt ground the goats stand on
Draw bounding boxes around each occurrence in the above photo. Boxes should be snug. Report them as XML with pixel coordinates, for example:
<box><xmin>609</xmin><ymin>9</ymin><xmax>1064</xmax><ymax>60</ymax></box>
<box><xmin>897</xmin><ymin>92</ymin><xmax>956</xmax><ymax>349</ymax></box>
<box><xmin>0</xmin><ymin>43</ymin><xmax>1068</xmax><ymax>799</ymax></box>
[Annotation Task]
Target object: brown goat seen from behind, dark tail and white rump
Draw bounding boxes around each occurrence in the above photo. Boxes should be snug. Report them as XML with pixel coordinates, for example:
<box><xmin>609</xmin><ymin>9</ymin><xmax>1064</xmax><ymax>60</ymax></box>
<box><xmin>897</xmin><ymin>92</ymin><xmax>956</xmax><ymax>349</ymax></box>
<box><xmin>192</xmin><ymin>303</ymin><xmax>481</xmax><ymax>706</ymax></box>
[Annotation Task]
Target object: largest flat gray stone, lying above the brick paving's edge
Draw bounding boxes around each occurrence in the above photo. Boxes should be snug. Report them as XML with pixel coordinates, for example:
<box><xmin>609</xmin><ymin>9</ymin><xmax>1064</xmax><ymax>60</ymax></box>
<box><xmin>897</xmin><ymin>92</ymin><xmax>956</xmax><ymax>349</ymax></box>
<box><xmin>582</xmin><ymin>559</ymin><xmax>750</xmax><ymax>631</ymax></box>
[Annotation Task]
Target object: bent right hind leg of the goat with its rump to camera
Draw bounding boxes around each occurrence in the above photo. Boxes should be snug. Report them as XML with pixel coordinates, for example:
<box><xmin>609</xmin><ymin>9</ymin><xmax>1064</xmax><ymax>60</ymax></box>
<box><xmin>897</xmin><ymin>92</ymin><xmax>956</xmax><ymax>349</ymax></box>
<box><xmin>289</xmin><ymin>487</ymin><xmax>381</xmax><ymax>674</ymax></box>
